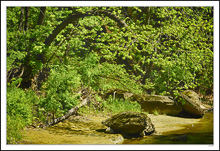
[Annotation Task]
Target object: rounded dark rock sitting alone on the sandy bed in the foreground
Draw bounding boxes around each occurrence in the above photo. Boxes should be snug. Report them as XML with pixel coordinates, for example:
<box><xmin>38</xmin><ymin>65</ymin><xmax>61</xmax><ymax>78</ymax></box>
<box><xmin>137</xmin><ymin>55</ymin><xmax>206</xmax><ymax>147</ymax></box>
<box><xmin>102</xmin><ymin>111</ymin><xmax>155</xmax><ymax>136</ymax></box>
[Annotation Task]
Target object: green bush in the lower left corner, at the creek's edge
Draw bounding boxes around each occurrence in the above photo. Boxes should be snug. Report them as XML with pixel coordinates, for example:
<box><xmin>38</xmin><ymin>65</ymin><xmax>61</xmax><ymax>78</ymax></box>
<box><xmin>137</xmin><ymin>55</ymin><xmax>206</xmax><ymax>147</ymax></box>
<box><xmin>7</xmin><ymin>87</ymin><xmax>37</xmax><ymax>144</ymax></box>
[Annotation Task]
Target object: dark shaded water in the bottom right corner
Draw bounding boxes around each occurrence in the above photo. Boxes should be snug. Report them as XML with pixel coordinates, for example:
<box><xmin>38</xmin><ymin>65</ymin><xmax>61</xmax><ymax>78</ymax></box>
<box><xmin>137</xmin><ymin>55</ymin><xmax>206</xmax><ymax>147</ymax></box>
<box><xmin>123</xmin><ymin>113</ymin><xmax>213</xmax><ymax>144</ymax></box>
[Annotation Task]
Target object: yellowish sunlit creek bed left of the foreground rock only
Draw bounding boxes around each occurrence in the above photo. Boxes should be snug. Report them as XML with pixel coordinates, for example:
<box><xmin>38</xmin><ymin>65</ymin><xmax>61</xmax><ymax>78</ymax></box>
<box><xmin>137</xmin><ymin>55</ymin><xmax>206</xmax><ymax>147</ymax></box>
<box><xmin>20</xmin><ymin>116</ymin><xmax>123</xmax><ymax>144</ymax></box>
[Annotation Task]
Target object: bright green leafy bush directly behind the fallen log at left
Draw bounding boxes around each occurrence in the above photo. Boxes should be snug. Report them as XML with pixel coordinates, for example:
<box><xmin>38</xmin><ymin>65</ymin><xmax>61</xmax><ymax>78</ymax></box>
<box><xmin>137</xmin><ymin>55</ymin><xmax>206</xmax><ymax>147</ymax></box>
<box><xmin>40</xmin><ymin>65</ymin><xmax>81</xmax><ymax>116</ymax></box>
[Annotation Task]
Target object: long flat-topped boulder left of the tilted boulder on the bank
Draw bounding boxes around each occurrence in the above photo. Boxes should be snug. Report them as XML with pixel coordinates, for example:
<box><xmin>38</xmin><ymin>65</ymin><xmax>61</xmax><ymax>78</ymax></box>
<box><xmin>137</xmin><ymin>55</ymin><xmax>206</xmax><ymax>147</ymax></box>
<box><xmin>132</xmin><ymin>94</ymin><xmax>182</xmax><ymax>115</ymax></box>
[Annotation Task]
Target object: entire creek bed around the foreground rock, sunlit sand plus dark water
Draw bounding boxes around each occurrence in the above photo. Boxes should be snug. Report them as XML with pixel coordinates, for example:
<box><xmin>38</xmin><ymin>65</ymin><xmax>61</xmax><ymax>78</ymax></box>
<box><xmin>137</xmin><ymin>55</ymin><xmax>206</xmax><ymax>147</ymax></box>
<box><xmin>20</xmin><ymin>113</ymin><xmax>213</xmax><ymax>144</ymax></box>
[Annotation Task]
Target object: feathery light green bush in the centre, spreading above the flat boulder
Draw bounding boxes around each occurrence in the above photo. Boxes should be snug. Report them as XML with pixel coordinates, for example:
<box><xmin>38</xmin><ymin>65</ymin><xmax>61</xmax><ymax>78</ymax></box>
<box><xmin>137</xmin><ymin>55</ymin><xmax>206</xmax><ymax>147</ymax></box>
<box><xmin>76</xmin><ymin>52</ymin><xmax>142</xmax><ymax>93</ymax></box>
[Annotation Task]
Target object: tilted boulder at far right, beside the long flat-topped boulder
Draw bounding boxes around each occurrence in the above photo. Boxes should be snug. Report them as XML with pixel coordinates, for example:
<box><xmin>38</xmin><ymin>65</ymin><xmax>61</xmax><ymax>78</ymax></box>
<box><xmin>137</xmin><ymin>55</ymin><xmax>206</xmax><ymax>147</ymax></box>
<box><xmin>179</xmin><ymin>90</ymin><xmax>210</xmax><ymax>117</ymax></box>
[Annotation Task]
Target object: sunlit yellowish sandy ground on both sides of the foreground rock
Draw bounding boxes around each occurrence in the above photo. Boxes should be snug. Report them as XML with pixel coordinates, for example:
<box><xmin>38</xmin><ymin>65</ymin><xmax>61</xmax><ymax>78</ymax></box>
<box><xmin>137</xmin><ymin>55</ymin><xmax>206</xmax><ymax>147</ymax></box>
<box><xmin>20</xmin><ymin>114</ymin><xmax>208</xmax><ymax>144</ymax></box>
